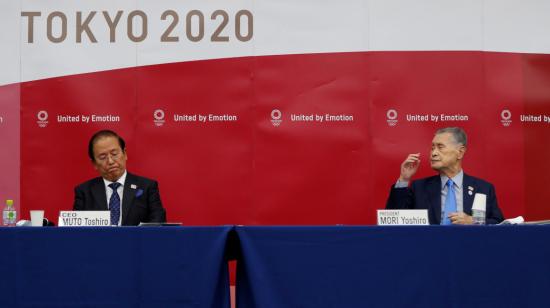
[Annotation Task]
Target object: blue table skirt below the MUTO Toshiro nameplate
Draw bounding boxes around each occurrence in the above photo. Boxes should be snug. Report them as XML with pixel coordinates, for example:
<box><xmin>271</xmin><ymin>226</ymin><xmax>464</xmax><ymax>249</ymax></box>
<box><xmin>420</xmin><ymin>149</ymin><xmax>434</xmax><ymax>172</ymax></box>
<box><xmin>0</xmin><ymin>227</ymin><xmax>232</xmax><ymax>308</ymax></box>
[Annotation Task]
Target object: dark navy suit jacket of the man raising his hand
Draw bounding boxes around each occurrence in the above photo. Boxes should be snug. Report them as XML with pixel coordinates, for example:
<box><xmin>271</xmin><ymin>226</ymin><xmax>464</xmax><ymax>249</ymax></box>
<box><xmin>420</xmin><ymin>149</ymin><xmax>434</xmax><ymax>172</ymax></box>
<box><xmin>386</xmin><ymin>174</ymin><xmax>504</xmax><ymax>225</ymax></box>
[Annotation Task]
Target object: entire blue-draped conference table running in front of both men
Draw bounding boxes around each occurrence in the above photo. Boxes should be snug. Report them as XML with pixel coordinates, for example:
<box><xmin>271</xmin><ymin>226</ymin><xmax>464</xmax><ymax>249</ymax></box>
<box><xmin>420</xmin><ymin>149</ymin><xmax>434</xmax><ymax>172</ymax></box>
<box><xmin>0</xmin><ymin>226</ymin><xmax>550</xmax><ymax>308</ymax></box>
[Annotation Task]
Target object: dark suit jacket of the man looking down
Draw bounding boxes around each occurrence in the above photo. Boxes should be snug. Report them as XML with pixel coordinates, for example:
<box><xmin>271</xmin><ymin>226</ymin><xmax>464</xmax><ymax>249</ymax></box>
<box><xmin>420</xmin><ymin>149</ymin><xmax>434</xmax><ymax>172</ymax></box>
<box><xmin>73</xmin><ymin>172</ymin><xmax>166</xmax><ymax>226</ymax></box>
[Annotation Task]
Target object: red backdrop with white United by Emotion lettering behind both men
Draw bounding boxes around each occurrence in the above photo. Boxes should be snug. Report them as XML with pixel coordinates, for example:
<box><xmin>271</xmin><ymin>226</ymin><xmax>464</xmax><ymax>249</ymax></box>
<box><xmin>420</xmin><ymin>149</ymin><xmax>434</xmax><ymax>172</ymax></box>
<box><xmin>12</xmin><ymin>51</ymin><xmax>550</xmax><ymax>225</ymax></box>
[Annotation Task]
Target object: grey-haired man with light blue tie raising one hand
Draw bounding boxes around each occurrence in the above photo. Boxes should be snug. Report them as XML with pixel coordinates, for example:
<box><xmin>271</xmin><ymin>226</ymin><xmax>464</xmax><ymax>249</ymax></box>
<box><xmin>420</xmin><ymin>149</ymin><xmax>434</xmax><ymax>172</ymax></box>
<box><xmin>386</xmin><ymin>127</ymin><xmax>504</xmax><ymax>225</ymax></box>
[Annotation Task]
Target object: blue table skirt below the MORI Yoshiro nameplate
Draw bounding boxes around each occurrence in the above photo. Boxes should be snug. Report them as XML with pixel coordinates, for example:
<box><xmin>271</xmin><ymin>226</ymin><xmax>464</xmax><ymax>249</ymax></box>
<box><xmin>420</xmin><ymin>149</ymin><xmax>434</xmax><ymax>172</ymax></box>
<box><xmin>236</xmin><ymin>226</ymin><xmax>550</xmax><ymax>308</ymax></box>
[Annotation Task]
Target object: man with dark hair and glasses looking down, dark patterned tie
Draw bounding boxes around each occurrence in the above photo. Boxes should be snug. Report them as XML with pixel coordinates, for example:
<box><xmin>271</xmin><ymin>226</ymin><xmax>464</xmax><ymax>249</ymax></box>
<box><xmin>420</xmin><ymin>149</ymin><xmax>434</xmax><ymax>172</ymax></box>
<box><xmin>73</xmin><ymin>130</ymin><xmax>166</xmax><ymax>226</ymax></box>
